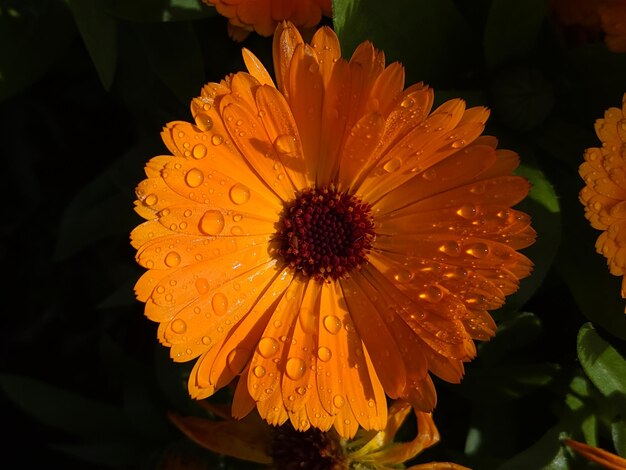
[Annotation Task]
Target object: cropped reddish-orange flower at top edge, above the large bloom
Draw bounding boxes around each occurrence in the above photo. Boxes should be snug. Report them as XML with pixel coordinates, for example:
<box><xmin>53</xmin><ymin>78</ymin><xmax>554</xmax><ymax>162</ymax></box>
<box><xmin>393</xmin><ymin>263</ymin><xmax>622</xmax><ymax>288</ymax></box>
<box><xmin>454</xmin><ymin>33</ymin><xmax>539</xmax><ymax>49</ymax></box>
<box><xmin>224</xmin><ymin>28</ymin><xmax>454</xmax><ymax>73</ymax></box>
<box><xmin>203</xmin><ymin>0</ymin><xmax>332</xmax><ymax>41</ymax></box>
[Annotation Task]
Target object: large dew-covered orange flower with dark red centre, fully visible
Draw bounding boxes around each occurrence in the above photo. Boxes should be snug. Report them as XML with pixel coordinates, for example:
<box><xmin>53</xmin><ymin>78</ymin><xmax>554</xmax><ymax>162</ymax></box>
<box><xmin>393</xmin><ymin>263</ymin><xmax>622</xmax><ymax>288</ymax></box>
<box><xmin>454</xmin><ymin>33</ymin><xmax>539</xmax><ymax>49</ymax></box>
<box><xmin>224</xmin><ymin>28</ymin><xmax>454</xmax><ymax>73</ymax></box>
<box><xmin>132</xmin><ymin>24</ymin><xmax>535</xmax><ymax>437</ymax></box>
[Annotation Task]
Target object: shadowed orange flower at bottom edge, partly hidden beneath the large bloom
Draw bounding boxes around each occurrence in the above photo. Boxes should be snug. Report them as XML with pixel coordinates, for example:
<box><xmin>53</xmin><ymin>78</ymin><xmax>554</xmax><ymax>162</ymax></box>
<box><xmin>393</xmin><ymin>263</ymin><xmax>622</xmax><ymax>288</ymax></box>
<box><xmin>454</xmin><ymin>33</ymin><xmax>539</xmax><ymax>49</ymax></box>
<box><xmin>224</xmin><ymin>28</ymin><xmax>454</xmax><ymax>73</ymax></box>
<box><xmin>170</xmin><ymin>402</ymin><xmax>469</xmax><ymax>470</ymax></box>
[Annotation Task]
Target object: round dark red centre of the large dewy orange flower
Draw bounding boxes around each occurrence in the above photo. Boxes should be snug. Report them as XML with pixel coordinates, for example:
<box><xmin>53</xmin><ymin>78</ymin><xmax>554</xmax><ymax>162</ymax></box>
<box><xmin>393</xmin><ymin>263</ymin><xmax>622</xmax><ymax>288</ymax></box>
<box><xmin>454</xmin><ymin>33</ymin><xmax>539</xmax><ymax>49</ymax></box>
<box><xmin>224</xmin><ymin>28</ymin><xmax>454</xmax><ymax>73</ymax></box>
<box><xmin>278</xmin><ymin>187</ymin><xmax>375</xmax><ymax>280</ymax></box>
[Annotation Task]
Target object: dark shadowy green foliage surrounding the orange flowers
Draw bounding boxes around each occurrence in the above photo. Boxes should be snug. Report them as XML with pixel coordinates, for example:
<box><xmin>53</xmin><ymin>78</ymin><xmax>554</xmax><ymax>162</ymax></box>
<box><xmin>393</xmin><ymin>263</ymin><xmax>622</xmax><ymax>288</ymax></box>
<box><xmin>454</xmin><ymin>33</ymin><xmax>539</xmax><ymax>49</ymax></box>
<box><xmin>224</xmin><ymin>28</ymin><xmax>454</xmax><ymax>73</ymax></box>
<box><xmin>0</xmin><ymin>0</ymin><xmax>626</xmax><ymax>470</ymax></box>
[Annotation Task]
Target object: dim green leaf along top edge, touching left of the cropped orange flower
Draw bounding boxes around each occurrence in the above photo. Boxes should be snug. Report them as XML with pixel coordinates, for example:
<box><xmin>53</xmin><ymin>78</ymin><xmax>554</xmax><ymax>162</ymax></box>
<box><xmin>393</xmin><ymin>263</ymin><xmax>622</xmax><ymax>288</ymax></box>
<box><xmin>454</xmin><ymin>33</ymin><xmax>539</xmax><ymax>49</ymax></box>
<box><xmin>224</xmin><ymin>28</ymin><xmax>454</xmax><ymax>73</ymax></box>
<box><xmin>99</xmin><ymin>0</ymin><xmax>217</xmax><ymax>23</ymax></box>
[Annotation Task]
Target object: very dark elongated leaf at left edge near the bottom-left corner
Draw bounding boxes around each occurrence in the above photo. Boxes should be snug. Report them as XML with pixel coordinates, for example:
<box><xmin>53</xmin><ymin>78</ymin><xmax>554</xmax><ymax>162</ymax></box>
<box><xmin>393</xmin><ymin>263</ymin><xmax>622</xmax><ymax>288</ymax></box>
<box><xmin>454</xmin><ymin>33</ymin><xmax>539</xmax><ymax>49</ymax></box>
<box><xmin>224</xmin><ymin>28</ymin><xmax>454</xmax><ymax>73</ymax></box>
<box><xmin>0</xmin><ymin>374</ymin><xmax>134</xmax><ymax>442</ymax></box>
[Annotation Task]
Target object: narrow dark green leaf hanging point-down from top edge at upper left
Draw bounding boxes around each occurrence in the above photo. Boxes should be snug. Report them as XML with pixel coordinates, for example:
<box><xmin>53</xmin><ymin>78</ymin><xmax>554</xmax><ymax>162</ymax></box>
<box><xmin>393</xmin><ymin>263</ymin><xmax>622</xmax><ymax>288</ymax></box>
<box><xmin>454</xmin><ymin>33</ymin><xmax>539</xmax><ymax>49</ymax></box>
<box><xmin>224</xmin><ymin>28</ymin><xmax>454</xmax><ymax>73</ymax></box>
<box><xmin>69</xmin><ymin>0</ymin><xmax>117</xmax><ymax>90</ymax></box>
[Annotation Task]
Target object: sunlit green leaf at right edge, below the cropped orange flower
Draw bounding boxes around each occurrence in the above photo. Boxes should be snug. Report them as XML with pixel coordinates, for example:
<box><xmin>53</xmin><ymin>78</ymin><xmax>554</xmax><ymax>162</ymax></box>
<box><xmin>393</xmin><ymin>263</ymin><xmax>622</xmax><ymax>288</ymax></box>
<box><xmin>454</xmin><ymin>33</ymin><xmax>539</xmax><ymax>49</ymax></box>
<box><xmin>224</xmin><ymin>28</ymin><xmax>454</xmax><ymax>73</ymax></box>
<box><xmin>578</xmin><ymin>323</ymin><xmax>626</xmax><ymax>397</ymax></box>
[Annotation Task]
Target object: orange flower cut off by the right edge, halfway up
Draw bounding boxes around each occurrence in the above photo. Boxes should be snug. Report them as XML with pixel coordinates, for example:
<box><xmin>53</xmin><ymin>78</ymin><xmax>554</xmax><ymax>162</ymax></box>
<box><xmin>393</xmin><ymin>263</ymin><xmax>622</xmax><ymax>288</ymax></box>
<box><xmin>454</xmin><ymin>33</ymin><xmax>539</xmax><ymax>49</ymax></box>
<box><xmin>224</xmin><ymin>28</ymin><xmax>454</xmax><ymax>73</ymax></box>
<box><xmin>578</xmin><ymin>95</ymin><xmax>626</xmax><ymax>304</ymax></box>
